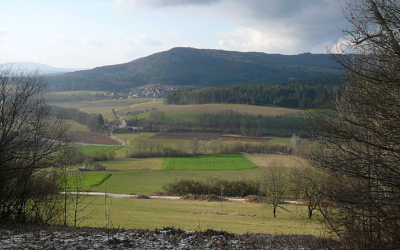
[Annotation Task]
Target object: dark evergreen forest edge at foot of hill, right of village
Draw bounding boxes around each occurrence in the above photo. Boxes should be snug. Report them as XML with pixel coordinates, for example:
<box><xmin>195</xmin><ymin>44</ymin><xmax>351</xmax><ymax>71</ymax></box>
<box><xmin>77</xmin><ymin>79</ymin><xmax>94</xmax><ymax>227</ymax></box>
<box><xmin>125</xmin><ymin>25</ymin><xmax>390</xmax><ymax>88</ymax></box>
<box><xmin>165</xmin><ymin>76</ymin><xmax>342</xmax><ymax>109</ymax></box>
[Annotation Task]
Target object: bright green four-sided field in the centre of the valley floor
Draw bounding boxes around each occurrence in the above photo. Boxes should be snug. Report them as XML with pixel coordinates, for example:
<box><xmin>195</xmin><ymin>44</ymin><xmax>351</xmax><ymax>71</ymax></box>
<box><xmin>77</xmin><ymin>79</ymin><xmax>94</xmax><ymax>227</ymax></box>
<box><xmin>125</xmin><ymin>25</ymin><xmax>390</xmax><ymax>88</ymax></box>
<box><xmin>162</xmin><ymin>153</ymin><xmax>257</xmax><ymax>171</ymax></box>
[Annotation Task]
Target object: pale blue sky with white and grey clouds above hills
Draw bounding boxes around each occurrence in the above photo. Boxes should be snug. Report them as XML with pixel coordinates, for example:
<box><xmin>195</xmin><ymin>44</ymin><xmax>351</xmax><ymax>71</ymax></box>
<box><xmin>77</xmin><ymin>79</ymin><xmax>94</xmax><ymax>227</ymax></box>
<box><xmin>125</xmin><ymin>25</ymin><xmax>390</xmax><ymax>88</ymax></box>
<box><xmin>0</xmin><ymin>0</ymin><xmax>348</xmax><ymax>68</ymax></box>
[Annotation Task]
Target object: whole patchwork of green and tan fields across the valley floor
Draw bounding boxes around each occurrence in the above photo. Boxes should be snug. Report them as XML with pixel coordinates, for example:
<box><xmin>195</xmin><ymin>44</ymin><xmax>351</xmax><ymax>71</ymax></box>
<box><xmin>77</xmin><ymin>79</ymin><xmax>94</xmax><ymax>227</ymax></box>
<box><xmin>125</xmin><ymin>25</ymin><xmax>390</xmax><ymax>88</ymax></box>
<box><xmin>46</xmin><ymin>94</ymin><xmax>316</xmax><ymax>235</ymax></box>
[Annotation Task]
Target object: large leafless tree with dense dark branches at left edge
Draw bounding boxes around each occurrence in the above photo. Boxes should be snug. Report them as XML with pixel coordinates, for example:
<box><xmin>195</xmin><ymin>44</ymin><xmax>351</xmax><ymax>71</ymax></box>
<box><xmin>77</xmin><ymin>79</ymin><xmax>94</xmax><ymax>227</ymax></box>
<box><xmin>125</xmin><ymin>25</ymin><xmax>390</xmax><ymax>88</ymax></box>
<box><xmin>0</xmin><ymin>64</ymin><xmax>69</xmax><ymax>221</ymax></box>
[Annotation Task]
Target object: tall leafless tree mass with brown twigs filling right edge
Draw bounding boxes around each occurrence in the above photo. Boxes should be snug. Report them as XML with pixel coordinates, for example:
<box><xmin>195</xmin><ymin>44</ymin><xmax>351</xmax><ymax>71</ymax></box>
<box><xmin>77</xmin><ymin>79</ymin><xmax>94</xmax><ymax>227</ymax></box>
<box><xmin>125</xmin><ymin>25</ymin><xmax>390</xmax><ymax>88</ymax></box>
<box><xmin>309</xmin><ymin>0</ymin><xmax>400</xmax><ymax>249</ymax></box>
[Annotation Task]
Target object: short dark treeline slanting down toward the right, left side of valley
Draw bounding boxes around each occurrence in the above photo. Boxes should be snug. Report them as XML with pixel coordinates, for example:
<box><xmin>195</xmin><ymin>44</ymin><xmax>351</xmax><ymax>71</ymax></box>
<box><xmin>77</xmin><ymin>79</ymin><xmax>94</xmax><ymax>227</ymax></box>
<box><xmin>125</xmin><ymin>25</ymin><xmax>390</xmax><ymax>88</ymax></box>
<box><xmin>49</xmin><ymin>105</ymin><xmax>107</xmax><ymax>132</ymax></box>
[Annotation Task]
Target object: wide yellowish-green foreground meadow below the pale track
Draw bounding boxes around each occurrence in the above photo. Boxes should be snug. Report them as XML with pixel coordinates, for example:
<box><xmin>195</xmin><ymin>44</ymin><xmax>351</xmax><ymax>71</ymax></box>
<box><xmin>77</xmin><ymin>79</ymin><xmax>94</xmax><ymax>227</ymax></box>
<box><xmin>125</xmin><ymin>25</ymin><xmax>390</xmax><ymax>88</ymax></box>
<box><xmin>71</xmin><ymin>197</ymin><xmax>324</xmax><ymax>236</ymax></box>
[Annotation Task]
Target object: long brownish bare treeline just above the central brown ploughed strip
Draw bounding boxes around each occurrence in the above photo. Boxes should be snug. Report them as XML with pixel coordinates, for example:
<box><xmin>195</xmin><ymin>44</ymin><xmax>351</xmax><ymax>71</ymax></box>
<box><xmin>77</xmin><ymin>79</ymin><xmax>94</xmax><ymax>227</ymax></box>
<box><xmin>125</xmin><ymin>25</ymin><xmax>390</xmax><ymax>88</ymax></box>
<box><xmin>125</xmin><ymin>109</ymin><xmax>308</xmax><ymax>137</ymax></box>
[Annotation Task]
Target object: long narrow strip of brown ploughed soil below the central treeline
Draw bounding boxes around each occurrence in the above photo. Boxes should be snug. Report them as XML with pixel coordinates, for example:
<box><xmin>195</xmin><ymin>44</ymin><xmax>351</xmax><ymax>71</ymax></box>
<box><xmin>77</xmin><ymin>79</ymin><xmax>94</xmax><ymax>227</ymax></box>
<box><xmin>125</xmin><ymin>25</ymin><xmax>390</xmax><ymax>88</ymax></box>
<box><xmin>149</xmin><ymin>132</ymin><xmax>272</xmax><ymax>142</ymax></box>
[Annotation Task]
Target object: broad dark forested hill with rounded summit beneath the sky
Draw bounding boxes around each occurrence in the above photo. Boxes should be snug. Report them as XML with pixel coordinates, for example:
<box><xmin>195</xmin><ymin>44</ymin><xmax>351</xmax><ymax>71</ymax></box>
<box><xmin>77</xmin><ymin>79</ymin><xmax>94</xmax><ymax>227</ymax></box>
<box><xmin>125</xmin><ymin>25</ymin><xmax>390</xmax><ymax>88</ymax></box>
<box><xmin>49</xmin><ymin>48</ymin><xmax>339</xmax><ymax>90</ymax></box>
